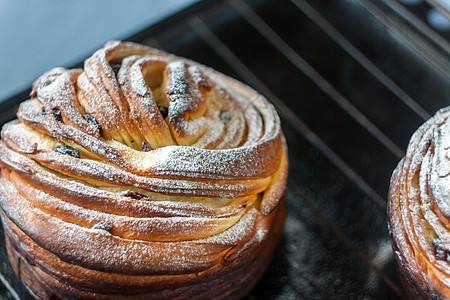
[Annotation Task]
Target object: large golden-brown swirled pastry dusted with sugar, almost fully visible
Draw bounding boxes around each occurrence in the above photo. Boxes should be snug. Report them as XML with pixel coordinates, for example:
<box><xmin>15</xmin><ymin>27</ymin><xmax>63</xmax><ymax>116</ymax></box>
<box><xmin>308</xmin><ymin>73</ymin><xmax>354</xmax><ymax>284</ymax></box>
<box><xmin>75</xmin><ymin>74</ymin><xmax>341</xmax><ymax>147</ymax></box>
<box><xmin>0</xmin><ymin>42</ymin><xmax>288</xmax><ymax>299</ymax></box>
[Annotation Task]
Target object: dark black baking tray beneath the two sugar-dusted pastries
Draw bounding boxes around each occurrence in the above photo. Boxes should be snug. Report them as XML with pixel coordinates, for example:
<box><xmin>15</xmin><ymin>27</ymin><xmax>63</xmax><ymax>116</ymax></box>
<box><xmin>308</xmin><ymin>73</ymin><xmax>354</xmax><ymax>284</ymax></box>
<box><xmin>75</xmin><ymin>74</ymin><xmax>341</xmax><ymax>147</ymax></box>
<box><xmin>0</xmin><ymin>0</ymin><xmax>450</xmax><ymax>299</ymax></box>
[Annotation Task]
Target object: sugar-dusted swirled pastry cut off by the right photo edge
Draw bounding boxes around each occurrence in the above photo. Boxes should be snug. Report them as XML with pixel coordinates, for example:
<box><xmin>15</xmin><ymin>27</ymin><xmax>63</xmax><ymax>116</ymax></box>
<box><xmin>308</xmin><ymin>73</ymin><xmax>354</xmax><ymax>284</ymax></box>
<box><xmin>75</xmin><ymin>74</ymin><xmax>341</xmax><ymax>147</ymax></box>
<box><xmin>388</xmin><ymin>108</ymin><xmax>450</xmax><ymax>299</ymax></box>
